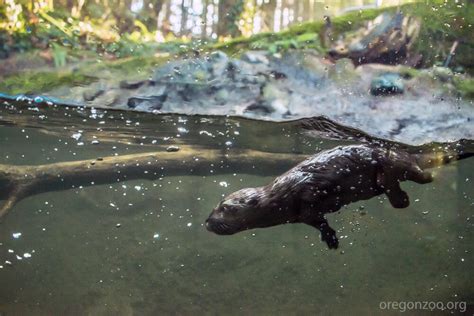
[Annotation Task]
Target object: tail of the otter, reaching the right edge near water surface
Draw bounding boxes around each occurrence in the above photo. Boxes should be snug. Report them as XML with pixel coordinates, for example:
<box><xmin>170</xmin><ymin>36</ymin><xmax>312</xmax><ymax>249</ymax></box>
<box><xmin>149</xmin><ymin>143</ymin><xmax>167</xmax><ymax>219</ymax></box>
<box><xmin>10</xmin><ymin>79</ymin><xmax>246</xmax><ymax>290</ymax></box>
<box><xmin>412</xmin><ymin>139</ymin><xmax>474</xmax><ymax>169</ymax></box>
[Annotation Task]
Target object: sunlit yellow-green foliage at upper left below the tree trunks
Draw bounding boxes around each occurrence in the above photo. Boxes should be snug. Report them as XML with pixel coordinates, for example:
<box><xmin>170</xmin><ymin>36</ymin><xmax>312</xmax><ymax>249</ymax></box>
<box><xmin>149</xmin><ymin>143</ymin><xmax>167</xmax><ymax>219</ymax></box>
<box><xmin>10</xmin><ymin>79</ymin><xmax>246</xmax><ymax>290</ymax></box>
<box><xmin>0</xmin><ymin>5</ymin><xmax>183</xmax><ymax>59</ymax></box>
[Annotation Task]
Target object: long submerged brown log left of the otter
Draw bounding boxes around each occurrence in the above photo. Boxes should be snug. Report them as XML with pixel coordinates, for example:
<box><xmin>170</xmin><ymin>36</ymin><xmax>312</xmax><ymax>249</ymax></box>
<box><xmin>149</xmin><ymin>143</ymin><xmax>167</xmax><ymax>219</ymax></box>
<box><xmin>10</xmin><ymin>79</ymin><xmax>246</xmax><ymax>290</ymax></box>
<box><xmin>0</xmin><ymin>146</ymin><xmax>306</xmax><ymax>220</ymax></box>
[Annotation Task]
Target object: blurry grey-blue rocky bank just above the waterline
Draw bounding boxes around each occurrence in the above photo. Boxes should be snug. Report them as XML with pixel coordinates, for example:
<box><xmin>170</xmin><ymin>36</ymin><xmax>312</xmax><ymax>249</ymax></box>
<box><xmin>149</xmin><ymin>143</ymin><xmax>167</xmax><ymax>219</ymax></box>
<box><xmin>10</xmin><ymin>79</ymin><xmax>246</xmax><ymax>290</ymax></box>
<box><xmin>32</xmin><ymin>50</ymin><xmax>474</xmax><ymax>143</ymax></box>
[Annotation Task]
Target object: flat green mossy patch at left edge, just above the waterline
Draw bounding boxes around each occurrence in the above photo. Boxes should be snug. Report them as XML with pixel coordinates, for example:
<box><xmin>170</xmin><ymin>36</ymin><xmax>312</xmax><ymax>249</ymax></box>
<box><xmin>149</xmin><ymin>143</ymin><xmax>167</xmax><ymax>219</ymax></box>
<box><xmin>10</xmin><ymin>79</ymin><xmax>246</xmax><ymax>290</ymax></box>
<box><xmin>0</xmin><ymin>71</ymin><xmax>96</xmax><ymax>95</ymax></box>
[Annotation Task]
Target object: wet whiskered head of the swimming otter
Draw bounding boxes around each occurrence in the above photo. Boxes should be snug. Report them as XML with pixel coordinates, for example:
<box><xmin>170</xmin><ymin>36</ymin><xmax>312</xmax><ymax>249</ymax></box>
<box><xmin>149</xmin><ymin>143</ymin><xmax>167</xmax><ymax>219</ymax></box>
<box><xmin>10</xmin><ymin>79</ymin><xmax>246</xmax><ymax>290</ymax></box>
<box><xmin>206</xmin><ymin>188</ymin><xmax>264</xmax><ymax>235</ymax></box>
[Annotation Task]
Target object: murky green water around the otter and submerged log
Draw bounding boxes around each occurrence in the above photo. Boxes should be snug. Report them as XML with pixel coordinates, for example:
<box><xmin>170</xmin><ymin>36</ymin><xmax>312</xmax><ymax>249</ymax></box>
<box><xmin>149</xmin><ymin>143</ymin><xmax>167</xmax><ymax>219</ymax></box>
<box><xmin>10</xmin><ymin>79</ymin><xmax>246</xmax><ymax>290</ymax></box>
<box><xmin>0</xmin><ymin>105</ymin><xmax>474</xmax><ymax>315</ymax></box>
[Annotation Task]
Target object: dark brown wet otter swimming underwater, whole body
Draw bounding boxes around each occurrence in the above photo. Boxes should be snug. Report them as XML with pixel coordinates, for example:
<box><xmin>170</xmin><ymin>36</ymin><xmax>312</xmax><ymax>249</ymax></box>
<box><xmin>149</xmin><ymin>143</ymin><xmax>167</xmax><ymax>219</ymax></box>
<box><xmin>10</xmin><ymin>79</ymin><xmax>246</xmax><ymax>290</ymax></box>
<box><xmin>206</xmin><ymin>143</ymin><xmax>472</xmax><ymax>249</ymax></box>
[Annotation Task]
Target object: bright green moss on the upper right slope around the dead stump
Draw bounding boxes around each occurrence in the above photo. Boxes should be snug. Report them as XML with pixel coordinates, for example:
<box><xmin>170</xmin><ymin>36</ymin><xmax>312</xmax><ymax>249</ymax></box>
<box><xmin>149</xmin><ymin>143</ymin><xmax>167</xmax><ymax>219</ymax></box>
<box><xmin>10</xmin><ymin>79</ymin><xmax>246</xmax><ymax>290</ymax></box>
<box><xmin>205</xmin><ymin>0</ymin><xmax>474</xmax><ymax>73</ymax></box>
